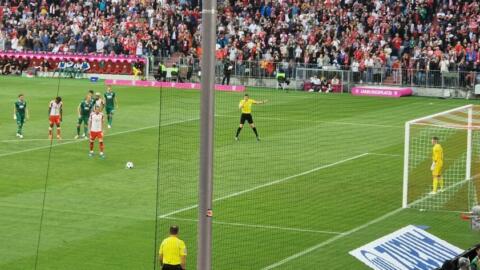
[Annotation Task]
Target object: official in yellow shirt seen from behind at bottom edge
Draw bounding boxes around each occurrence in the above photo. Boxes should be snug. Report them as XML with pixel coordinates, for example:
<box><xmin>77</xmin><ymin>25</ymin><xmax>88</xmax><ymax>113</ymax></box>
<box><xmin>158</xmin><ymin>226</ymin><xmax>187</xmax><ymax>270</ymax></box>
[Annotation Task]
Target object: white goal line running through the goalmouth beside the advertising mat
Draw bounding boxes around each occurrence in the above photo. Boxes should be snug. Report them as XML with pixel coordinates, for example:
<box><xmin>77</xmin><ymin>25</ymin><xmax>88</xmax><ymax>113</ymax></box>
<box><xmin>262</xmin><ymin>169</ymin><xmax>470</xmax><ymax>270</ymax></box>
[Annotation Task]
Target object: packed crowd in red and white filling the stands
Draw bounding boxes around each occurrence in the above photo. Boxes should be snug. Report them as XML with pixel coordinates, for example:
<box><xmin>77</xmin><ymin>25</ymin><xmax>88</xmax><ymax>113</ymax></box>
<box><xmin>0</xmin><ymin>0</ymin><xmax>480</xmax><ymax>84</ymax></box>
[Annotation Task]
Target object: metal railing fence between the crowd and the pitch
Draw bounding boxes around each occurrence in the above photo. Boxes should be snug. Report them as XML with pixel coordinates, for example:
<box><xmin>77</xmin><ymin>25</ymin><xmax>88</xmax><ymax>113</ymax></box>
<box><xmin>150</xmin><ymin>57</ymin><xmax>480</xmax><ymax>92</ymax></box>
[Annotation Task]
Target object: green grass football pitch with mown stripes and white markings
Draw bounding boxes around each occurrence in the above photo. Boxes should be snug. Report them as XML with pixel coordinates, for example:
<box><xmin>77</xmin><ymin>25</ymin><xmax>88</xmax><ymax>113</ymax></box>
<box><xmin>0</xmin><ymin>77</ymin><xmax>478</xmax><ymax>270</ymax></box>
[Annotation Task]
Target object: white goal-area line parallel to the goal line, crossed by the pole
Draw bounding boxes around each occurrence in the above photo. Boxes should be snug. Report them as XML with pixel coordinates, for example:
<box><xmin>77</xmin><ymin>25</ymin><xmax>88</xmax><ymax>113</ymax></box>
<box><xmin>159</xmin><ymin>153</ymin><xmax>368</xmax><ymax>218</ymax></box>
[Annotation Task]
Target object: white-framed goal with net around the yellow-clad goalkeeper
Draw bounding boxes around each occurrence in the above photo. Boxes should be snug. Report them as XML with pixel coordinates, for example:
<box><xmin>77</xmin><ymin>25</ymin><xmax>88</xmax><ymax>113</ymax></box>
<box><xmin>402</xmin><ymin>105</ymin><xmax>480</xmax><ymax>211</ymax></box>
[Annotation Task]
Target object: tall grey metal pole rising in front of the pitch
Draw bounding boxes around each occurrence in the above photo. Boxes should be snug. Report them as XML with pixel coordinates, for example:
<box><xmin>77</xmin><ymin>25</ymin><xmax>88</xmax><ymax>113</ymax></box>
<box><xmin>197</xmin><ymin>0</ymin><xmax>217</xmax><ymax>270</ymax></box>
